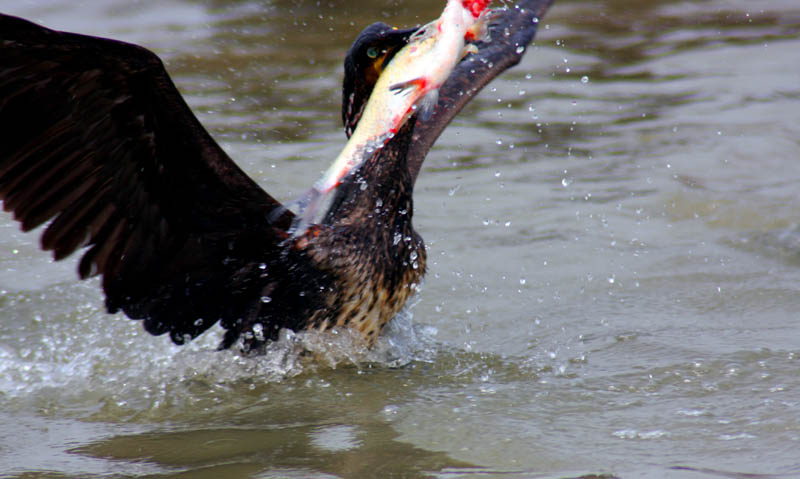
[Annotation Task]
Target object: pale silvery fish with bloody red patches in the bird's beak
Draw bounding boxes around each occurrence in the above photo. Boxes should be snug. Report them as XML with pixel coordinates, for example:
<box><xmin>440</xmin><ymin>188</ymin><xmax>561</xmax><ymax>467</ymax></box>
<box><xmin>291</xmin><ymin>0</ymin><xmax>492</xmax><ymax>232</ymax></box>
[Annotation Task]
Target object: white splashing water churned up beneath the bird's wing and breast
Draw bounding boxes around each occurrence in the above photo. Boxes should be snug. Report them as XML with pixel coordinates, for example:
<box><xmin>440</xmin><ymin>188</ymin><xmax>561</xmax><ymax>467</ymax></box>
<box><xmin>0</xmin><ymin>285</ymin><xmax>434</xmax><ymax>421</ymax></box>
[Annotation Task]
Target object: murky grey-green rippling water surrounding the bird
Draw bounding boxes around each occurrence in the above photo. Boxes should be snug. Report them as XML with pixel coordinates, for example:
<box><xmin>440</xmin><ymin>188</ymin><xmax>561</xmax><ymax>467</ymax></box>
<box><xmin>0</xmin><ymin>0</ymin><xmax>800</xmax><ymax>479</ymax></box>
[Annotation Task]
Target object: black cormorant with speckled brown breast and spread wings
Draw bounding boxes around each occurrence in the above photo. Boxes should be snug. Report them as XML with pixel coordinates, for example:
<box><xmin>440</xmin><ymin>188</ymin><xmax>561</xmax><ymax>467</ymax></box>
<box><xmin>0</xmin><ymin>0</ymin><xmax>552</xmax><ymax>351</ymax></box>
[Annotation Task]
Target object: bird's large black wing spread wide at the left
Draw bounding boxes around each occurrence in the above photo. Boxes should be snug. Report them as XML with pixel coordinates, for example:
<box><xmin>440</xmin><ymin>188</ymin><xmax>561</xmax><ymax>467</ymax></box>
<box><xmin>0</xmin><ymin>15</ymin><xmax>291</xmax><ymax>343</ymax></box>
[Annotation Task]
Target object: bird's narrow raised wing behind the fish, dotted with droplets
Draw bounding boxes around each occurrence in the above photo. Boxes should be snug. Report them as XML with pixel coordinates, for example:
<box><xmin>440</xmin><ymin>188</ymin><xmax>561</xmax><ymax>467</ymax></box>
<box><xmin>407</xmin><ymin>0</ymin><xmax>554</xmax><ymax>180</ymax></box>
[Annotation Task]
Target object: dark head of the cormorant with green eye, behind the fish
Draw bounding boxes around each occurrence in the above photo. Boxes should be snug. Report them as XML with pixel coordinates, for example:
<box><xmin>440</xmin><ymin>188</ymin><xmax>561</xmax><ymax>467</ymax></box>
<box><xmin>342</xmin><ymin>22</ymin><xmax>417</xmax><ymax>138</ymax></box>
